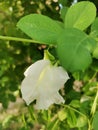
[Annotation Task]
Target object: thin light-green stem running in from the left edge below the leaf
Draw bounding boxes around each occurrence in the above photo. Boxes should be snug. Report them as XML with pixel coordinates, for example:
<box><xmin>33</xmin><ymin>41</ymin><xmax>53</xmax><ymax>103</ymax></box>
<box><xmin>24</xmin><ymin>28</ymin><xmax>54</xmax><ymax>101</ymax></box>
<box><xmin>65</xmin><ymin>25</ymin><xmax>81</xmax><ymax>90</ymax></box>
<box><xmin>0</xmin><ymin>36</ymin><xmax>45</xmax><ymax>44</ymax></box>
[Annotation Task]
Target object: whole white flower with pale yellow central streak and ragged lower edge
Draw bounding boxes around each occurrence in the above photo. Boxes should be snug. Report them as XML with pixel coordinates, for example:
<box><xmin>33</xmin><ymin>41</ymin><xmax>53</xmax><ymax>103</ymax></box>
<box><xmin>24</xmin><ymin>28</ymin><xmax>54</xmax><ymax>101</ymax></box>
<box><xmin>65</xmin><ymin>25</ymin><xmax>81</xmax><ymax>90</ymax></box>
<box><xmin>21</xmin><ymin>60</ymin><xmax>69</xmax><ymax>109</ymax></box>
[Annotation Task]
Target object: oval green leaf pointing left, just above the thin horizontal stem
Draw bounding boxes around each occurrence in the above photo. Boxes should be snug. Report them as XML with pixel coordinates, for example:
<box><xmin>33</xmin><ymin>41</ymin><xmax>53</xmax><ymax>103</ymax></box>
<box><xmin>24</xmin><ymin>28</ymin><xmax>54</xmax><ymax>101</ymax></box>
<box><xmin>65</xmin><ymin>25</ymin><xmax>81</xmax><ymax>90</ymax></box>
<box><xmin>17</xmin><ymin>14</ymin><xmax>62</xmax><ymax>44</ymax></box>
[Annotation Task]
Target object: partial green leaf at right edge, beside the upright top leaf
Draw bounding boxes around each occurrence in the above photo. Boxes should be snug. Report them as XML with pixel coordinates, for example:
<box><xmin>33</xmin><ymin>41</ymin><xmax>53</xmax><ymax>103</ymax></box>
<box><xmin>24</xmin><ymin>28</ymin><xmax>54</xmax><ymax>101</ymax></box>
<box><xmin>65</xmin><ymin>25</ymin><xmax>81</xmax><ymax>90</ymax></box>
<box><xmin>90</xmin><ymin>17</ymin><xmax>98</xmax><ymax>38</ymax></box>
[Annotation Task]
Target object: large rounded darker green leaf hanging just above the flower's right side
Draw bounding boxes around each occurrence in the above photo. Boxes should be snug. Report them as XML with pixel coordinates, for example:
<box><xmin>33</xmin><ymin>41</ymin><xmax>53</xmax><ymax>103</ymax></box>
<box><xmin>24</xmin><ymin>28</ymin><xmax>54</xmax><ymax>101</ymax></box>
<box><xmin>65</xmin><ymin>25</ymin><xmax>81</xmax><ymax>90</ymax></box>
<box><xmin>56</xmin><ymin>28</ymin><xmax>95</xmax><ymax>72</ymax></box>
